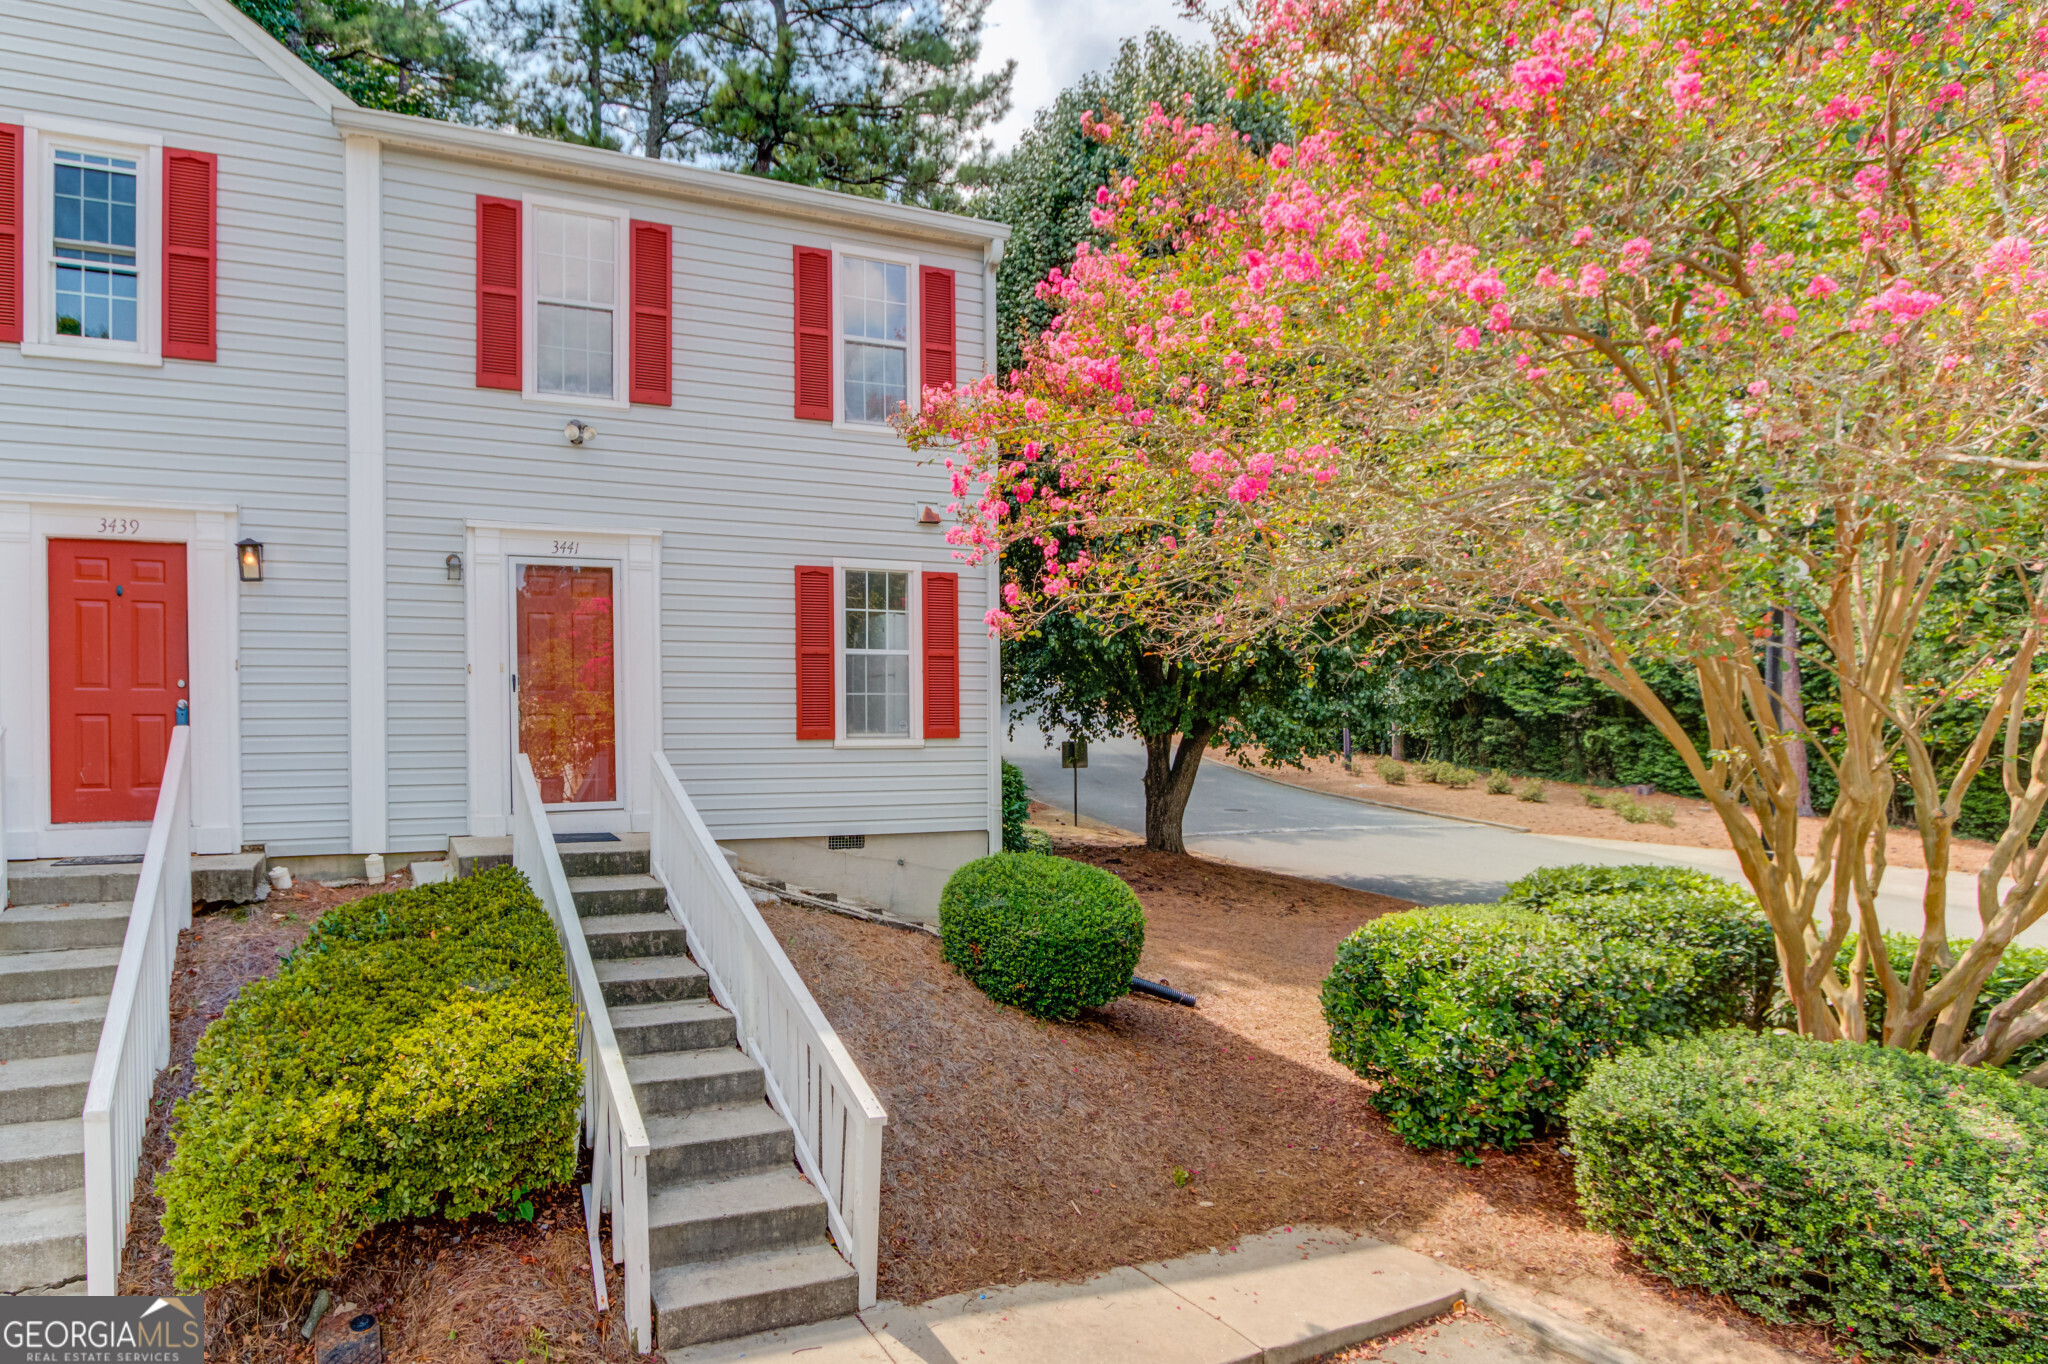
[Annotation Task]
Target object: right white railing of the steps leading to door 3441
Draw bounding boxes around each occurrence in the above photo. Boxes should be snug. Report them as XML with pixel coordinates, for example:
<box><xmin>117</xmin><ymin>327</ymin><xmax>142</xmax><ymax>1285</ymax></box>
<box><xmin>649</xmin><ymin>750</ymin><xmax>889</xmax><ymax>1307</ymax></box>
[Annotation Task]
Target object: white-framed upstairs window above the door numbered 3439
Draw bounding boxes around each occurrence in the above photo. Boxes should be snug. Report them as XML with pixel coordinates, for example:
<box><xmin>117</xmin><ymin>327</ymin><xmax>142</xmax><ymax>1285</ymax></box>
<box><xmin>23</xmin><ymin>119</ymin><xmax>164</xmax><ymax>365</ymax></box>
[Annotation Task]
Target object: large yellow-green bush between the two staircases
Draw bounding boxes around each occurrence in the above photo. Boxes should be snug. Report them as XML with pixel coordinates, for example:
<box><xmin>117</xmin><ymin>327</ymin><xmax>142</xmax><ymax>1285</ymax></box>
<box><xmin>158</xmin><ymin>866</ymin><xmax>584</xmax><ymax>1290</ymax></box>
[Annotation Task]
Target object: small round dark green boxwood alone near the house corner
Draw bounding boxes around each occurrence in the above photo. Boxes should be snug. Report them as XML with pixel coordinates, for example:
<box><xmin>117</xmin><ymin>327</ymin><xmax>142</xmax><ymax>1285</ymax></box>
<box><xmin>938</xmin><ymin>852</ymin><xmax>1145</xmax><ymax>1020</ymax></box>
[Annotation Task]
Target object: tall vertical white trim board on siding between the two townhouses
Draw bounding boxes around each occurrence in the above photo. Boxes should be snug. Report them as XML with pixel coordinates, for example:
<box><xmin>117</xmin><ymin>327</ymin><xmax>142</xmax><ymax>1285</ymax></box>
<box><xmin>342</xmin><ymin>137</ymin><xmax>391</xmax><ymax>852</ymax></box>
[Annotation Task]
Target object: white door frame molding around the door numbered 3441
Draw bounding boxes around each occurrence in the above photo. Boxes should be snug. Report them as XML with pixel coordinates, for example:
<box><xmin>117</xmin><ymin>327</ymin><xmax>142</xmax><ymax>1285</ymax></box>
<box><xmin>463</xmin><ymin>520</ymin><xmax>662</xmax><ymax>838</ymax></box>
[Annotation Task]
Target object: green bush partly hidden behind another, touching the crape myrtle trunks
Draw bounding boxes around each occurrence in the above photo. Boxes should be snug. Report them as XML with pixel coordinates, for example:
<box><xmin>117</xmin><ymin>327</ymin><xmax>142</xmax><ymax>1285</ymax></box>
<box><xmin>1501</xmin><ymin>866</ymin><xmax>1778</xmax><ymax>1028</ymax></box>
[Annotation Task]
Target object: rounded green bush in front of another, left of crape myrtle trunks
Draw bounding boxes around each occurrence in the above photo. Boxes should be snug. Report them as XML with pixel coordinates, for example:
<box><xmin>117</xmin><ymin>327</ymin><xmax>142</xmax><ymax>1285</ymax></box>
<box><xmin>1323</xmin><ymin>905</ymin><xmax>1692</xmax><ymax>1149</ymax></box>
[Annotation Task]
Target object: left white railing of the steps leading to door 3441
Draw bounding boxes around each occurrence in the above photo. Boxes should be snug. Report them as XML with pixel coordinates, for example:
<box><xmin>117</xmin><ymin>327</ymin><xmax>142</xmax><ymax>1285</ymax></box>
<box><xmin>512</xmin><ymin>754</ymin><xmax>653</xmax><ymax>1354</ymax></box>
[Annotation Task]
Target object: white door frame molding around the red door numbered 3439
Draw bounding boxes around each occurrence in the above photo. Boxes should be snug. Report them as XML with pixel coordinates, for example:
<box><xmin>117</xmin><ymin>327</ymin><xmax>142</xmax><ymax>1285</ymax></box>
<box><xmin>0</xmin><ymin>492</ymin><xmax>242</xmax><ymax>858</ymax></box>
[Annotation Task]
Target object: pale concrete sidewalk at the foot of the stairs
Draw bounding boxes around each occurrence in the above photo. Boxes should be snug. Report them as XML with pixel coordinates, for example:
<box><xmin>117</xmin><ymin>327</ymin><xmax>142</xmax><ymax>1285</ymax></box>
<box><xmin>668</xmin><ymin>1229</ymin><xmax>1636</xmax><ymax>1364</ymax></box>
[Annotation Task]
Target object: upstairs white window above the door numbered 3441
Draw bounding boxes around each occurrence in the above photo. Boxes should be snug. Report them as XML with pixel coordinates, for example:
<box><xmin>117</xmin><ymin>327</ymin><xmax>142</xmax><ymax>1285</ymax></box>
<box><xmin>532</xmin><ymin>209</ymin><xmax>618</xmax><ymax>397</ymax></box>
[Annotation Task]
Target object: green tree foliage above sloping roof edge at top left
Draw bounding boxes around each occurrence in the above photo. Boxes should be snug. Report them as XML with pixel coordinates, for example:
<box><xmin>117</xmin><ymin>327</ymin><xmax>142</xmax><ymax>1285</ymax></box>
<box><xmin>236</xmin><ymin>0</ymin><xmax>506</xmax><ymax>123</ymax></box>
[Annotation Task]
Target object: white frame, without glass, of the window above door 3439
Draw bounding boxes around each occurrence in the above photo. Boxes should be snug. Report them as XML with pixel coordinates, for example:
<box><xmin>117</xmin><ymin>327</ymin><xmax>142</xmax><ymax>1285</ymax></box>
<box><xmin>20</xmin><ymin>115</ymin><xmax>164</xmax><ymax>369</ymax></box>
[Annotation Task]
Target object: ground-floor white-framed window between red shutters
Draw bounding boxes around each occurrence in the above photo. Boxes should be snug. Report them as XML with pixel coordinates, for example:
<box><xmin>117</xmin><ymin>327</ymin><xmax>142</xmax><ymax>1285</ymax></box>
<box><xmin>836</xmin><ymin>561</ymin><xmax>924</xmax><ymax>748</ymax></box>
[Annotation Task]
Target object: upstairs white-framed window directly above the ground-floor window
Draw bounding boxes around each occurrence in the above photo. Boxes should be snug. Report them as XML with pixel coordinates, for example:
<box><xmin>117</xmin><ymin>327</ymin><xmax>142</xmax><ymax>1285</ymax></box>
<box><xmin>831</xmin><ymin>248</ymin><xmax>918</xmax><ymax>426</ymax></box>
